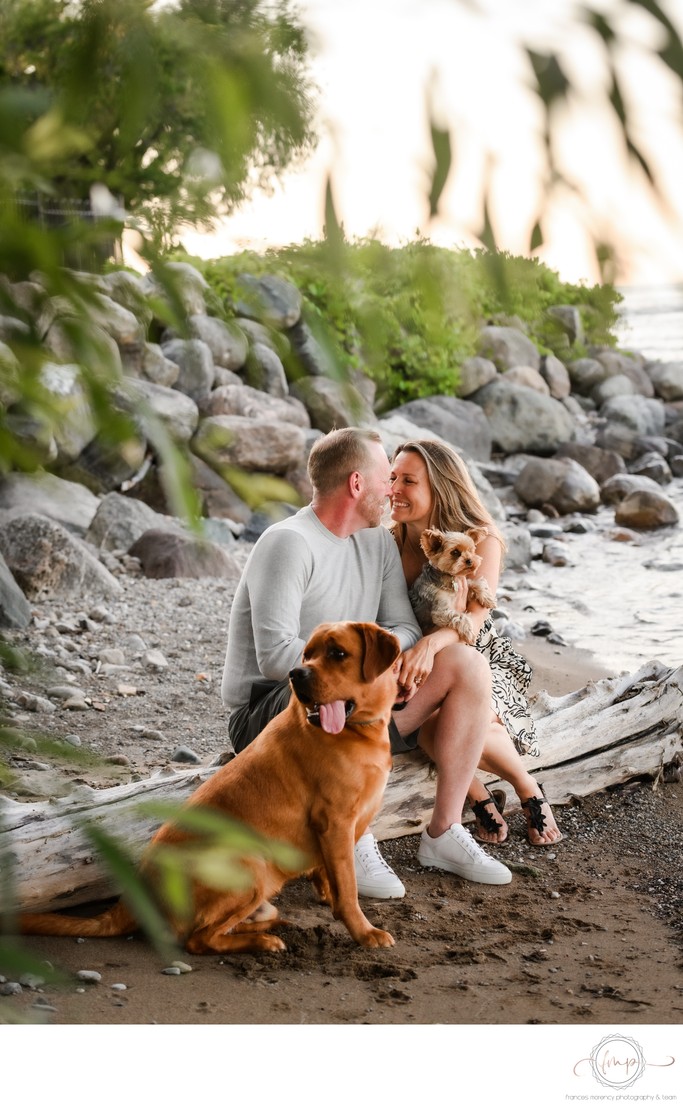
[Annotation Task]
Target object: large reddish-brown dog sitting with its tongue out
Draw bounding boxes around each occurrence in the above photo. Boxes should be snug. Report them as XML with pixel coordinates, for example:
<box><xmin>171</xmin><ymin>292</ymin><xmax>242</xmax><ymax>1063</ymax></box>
<box><xmin>20</xmin><ymin>622</ymin><xmax>400</xmax><ymax>953</ymax></box>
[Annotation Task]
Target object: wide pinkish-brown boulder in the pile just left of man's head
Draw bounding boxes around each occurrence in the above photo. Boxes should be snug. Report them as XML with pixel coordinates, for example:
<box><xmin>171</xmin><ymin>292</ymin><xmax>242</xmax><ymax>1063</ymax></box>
<box><xmin>192</xmin><ymin>415</ymin><xmax>306</xmax><ymax>475</ymax></box>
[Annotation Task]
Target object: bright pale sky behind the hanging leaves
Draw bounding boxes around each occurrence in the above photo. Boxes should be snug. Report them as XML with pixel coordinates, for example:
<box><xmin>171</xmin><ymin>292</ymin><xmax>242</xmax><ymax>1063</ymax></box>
<box><xmin>177</xmin><ymin>0</ymin><xmax>683</xmax><ymax>284</ymax></box>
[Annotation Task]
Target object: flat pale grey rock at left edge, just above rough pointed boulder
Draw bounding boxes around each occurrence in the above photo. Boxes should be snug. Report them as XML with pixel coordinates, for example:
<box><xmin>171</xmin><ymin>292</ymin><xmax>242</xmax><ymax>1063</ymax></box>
<box><xmin>0</xmin><ymin>473</ymin><xmax>100</xmax><ymax>535</ymax></box>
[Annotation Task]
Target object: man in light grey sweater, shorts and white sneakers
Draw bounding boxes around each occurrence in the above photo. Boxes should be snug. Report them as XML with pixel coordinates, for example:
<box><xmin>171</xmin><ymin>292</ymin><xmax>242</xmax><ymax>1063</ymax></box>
<box><xmin>221</xmin><ymin>427</ymin><xmax>510</xmax><ymax>899</ymax></box>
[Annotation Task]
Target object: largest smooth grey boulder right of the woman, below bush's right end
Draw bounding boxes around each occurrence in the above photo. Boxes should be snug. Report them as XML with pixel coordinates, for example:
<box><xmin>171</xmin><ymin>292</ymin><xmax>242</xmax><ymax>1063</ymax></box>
<box><xmin>469</xmin><ymin>379</ymin><xmax>575</xmax><ymax>454</ymax></box>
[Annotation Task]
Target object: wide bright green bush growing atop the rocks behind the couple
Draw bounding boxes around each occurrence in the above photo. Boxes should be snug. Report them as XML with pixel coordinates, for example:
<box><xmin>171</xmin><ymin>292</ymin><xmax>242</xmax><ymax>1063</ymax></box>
<box><xmin>183</xmin><ymin>239</ymin><xmax>621</xmax><ymax>411</ymax></box>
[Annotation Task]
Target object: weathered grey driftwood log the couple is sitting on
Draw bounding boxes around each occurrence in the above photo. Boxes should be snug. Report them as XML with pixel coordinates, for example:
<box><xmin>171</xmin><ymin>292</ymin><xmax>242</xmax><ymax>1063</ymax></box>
<box><xmin>0</xmin><ymin>661</ymin><xmax>683</xmax><ymax>910</ymax></box>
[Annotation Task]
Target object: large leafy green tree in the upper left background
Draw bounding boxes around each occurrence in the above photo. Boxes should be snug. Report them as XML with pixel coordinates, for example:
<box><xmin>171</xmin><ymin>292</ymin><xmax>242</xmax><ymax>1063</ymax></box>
<box><xmin>0</xmin><ymin>0</ymin><xmax>312</xmax><ymax>246</ymax></box>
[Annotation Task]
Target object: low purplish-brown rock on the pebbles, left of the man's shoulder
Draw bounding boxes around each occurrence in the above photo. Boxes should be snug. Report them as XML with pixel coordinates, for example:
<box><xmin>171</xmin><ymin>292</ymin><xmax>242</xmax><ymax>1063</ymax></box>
<box><xmin>128</xmin><ymin>530</ymin><xmax>240</xmax><ymax>580</ymax></box>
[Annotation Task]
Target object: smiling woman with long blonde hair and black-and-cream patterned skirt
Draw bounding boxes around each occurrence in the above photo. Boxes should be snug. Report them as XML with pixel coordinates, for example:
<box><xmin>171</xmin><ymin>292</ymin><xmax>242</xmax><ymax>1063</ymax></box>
<box><xmin>390</xmin><ymin>439</ymin><xmax>562</xmax><ymax>846</ymax></box>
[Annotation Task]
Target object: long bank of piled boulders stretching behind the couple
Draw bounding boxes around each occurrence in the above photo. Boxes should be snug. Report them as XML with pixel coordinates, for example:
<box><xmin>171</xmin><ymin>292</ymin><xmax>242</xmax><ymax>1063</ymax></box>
<box><xmin>0</xmin><ymin>256</ymin><xmax>683</xmax><ymax>627</ymax></box>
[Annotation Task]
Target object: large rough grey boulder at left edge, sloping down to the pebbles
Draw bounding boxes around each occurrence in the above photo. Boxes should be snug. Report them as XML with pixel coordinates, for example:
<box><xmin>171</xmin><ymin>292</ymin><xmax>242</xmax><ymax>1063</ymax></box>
<box><xmin>0</xmin><ymin>515</ymin><xmax>121</xmax><ymax>600</ymax></box>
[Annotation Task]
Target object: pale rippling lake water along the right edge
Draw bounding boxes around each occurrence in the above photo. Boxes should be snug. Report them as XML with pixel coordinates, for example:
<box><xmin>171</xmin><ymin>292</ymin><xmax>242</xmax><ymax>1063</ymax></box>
<box><xmin>501</xmin><ymin>284</ymin><xmax>683</xmax><ymax>672</ymax></box>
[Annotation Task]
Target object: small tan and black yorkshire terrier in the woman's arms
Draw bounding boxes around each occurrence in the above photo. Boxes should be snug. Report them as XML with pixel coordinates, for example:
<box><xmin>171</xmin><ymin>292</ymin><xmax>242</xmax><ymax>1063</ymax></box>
<box><xmin>410</xmin><ymin>528</ymin><xmax>496</xmax><ymax>645</ymax></box>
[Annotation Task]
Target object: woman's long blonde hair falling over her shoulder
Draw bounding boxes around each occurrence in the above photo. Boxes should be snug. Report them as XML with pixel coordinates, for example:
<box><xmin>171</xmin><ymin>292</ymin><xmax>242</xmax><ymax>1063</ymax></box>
<box><xmin>391</xmin><ymin>438</ymin><xmax>505</xmax><ymax>549</ymax></box>
